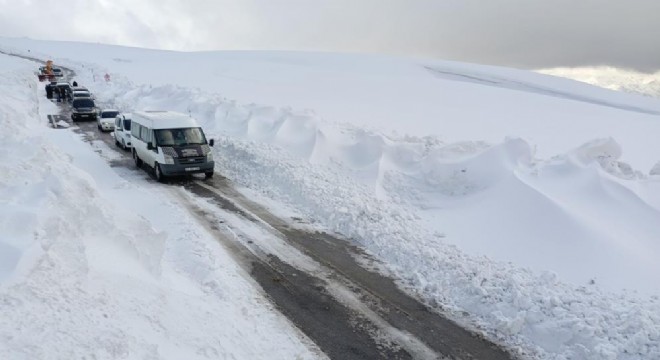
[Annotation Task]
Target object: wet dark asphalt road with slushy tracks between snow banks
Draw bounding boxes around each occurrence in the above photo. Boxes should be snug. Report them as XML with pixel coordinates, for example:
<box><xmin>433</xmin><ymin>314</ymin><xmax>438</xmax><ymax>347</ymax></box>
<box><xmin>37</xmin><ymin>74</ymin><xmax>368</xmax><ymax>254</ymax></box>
<box><xmin>33</xmin><ymin>54</ymin><xmax>514</xmax><ymax>360</ymax></box>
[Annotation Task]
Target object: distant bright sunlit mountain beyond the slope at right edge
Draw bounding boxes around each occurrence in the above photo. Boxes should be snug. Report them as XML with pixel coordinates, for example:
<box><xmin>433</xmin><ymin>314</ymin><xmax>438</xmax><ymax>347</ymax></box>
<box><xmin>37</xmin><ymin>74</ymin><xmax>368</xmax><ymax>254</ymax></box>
<box><xmin>538</xmin><ymin>66</ymin><xmax>660</xmax><ymax>98</ymax></box>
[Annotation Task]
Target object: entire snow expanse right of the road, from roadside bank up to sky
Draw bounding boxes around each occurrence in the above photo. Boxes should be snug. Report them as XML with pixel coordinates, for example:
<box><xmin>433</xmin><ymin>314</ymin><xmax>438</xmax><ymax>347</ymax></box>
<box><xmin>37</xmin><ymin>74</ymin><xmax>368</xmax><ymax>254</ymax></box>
<box><xmin>3</xmin><ymin>40</ymin><xmax>660</xmax><ymax>359</ymax></box>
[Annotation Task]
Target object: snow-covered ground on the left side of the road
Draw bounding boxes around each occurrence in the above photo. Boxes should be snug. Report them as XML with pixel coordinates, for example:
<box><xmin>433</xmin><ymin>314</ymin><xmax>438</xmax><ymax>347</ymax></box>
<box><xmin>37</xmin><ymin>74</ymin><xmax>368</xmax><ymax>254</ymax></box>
<box><xmin>0</xmin><ymin>55</ymin><xmax>323</xmax><ymax>359</ymax></box>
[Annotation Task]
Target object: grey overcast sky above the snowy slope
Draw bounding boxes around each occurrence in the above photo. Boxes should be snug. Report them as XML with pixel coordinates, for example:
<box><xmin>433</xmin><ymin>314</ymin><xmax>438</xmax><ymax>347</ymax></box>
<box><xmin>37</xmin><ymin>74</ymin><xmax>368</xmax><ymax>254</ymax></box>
<box><xmin>0</xmin><ymin>0</ymin><xmax>660</xmax><ymax>72</ymax></box>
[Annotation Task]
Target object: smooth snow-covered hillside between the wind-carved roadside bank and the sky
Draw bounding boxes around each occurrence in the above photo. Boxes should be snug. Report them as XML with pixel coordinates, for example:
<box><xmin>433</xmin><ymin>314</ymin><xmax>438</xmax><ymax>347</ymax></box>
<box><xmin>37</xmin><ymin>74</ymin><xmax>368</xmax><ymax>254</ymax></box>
<box><xmin>0</xmin><ymin>38</ymin><xmax>660</xmax><ymax>172</ymax></box>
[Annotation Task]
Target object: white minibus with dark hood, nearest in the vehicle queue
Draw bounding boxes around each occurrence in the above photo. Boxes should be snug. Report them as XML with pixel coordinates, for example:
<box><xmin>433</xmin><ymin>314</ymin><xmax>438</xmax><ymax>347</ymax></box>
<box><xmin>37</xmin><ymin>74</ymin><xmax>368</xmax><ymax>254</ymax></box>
<box><xmin>131</xmin><ymin>111</ymin><xmax>215</xmax><ymax>182</ymax></box>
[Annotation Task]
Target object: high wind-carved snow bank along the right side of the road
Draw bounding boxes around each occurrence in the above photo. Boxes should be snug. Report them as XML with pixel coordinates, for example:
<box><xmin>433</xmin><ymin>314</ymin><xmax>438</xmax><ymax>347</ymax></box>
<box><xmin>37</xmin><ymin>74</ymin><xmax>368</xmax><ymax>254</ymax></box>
<box><xmin>67</xmin><ymin>58</ymin><xmax>660</xmax><ymax>359</ymax></box>
